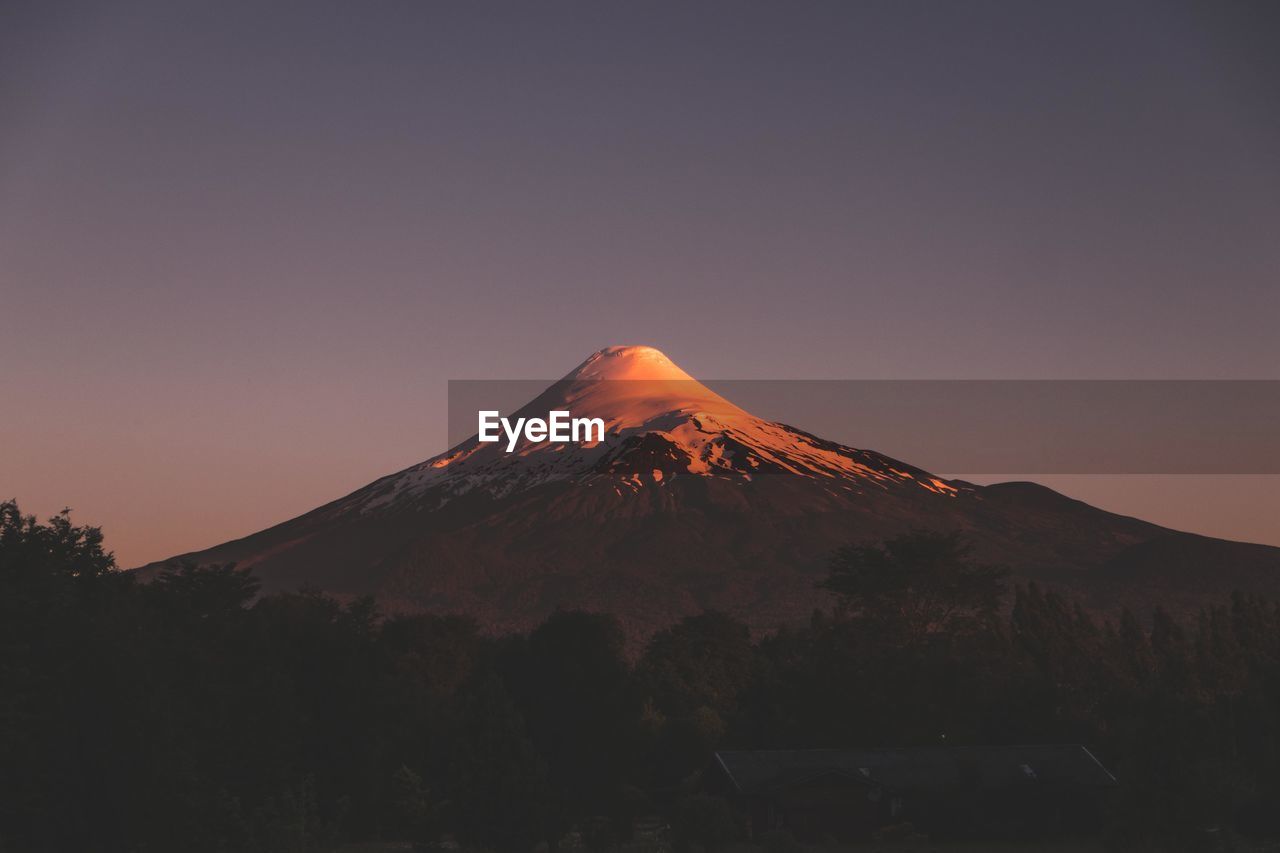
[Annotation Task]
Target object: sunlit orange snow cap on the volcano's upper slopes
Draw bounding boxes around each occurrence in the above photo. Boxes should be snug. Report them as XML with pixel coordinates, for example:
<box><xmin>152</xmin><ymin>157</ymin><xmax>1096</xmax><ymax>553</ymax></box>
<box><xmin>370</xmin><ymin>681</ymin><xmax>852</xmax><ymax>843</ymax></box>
<box><xmin>343</xmin><ymin>346</ymin><xmax>966</xmax><ymax>512</ymax></box>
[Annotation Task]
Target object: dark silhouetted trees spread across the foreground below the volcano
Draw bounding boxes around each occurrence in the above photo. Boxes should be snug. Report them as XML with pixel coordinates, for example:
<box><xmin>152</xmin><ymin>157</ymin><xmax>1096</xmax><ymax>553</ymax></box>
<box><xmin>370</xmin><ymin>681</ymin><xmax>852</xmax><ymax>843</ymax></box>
<box><xmin>0</xmin><ymin>502</ymin><xmax>1280</xmax><ymax>853</ymax></box>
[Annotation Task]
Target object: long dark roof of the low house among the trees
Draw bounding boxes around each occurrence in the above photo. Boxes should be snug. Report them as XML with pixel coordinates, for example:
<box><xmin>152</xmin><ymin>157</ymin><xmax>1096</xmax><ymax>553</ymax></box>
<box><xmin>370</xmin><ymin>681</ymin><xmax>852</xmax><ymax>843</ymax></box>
<box><xmin>716</xmin><ymin>744</ymin><xmax>1116</xmax><ymax>794</ymax></box>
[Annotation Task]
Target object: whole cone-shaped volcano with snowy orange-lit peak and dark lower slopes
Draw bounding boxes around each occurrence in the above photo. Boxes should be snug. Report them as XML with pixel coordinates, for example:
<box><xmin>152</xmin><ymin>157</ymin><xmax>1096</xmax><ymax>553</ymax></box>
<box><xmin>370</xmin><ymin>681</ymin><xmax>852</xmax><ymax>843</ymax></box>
<box><xmin>138</xmin><ymin>346</ymin><xmax>1280</xmax><ymax>638</ymax></box>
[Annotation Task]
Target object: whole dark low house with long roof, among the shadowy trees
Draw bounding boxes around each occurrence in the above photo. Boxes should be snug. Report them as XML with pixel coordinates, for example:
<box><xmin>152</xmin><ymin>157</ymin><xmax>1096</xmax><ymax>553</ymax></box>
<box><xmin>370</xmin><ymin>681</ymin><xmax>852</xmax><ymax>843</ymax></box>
<box><xmin>709</xmin><ymin>744</ymin><xmax>1116</xmax><ymax>840</ymax></box>
